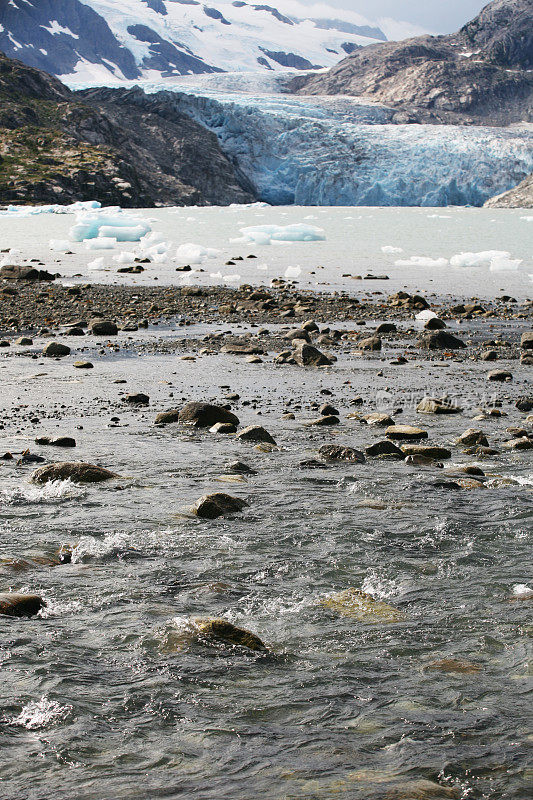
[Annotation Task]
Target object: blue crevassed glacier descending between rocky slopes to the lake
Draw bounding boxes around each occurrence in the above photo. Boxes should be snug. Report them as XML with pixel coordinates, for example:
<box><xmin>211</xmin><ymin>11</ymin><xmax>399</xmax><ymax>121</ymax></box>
<box><xmin>76</xmin><ymin>75</ymin><xmax>533</xmax><ymax>206</ymax></box>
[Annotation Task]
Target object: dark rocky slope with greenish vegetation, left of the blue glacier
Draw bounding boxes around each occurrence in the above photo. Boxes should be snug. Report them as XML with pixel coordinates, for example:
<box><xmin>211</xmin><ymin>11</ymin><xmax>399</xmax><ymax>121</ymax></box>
<box><xmin>0</xmin><ymin>54</ymin><xmax>255</xmax><ymax>207</ymax></box>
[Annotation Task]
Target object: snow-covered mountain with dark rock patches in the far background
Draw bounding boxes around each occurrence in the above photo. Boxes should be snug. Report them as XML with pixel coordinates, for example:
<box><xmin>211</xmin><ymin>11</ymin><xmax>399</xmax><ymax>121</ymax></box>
<box><xmin>0</xmin><ymin>0</ymin><xmax>386</xmax><ymax>83</ymax></box>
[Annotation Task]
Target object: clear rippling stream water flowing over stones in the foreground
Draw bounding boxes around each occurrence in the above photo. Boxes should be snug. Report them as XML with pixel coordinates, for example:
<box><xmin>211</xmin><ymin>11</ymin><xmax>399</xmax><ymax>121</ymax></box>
<box><xmin>0</xmin><ymin>316</ymin><xmax>533</xmax><ymax>800</ymax></box>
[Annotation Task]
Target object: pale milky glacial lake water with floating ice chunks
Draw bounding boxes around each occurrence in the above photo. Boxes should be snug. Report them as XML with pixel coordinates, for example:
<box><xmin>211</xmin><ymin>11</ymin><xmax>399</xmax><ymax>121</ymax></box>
<box><xmin>0</xmin><ymin>205</ymin><xmax>533</xmax><ymax>299</ymax></box>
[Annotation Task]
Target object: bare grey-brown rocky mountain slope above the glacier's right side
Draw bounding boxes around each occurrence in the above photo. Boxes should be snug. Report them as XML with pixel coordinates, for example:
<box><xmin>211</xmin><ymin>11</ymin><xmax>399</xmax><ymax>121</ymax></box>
<box><xmin>290</xmin><ymin>0</ymin><xmax>533</xmax><ymax>125</ymax></box>
